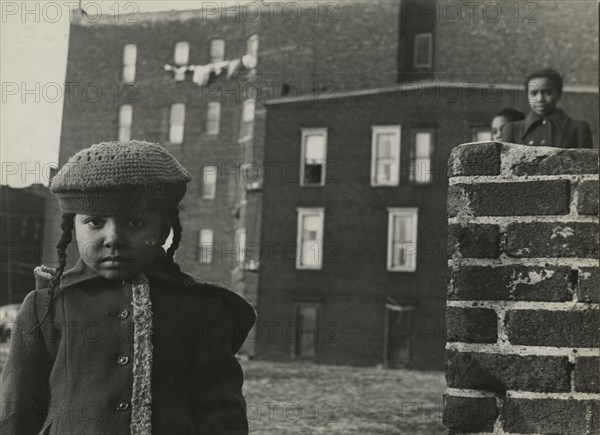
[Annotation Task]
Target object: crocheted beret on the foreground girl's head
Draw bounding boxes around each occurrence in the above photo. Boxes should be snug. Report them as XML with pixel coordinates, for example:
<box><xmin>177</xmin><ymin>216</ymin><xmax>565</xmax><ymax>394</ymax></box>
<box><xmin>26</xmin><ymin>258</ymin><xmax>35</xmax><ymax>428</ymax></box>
<box><xmin>50</xmin><ymin>140</ymin><xmax>192</xmax><ymax>216</ymax></box>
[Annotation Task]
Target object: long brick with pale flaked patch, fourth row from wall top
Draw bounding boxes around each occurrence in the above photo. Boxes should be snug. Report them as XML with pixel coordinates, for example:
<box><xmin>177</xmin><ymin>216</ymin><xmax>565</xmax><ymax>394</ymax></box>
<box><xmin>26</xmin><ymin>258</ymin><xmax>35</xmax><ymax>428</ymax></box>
<box><xmin>448</xmin><ymin>265</ymin><xmax>573</xmax><ymax>302</ymax></box>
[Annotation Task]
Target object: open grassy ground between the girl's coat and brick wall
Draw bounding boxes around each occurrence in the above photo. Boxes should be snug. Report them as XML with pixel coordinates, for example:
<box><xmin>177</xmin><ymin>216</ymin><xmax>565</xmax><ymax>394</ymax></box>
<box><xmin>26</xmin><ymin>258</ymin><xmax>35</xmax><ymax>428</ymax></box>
<box><xmin>242</xmin><ymin>361</ymin><xmax>447</xmax><ymax>435</ymax></box>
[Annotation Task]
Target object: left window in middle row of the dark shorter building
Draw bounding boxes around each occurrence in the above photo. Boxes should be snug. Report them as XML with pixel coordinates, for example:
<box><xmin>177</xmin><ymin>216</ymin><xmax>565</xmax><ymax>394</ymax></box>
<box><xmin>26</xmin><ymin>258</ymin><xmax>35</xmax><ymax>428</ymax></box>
<box><xmin>296</xmin><ymin>208</ymin><xmax>325</xmax><ymax>269</ymax></box>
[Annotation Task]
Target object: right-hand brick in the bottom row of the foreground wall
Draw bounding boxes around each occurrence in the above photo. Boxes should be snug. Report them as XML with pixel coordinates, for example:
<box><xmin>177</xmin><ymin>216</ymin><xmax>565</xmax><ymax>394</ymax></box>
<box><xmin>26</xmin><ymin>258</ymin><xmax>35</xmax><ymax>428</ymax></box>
<box><xmin>503</xmin><ymin>399</ymin><xmax>600</xmax><ymax>435</ymax></box>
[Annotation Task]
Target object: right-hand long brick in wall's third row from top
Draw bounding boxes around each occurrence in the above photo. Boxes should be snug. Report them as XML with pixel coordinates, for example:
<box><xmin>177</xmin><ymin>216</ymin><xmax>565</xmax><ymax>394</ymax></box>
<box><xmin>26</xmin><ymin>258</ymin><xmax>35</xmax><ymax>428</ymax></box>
<box><xmin>506</xmin><ymin>222</ymin><xmax>598</xmax><ymax>258</ymax></box>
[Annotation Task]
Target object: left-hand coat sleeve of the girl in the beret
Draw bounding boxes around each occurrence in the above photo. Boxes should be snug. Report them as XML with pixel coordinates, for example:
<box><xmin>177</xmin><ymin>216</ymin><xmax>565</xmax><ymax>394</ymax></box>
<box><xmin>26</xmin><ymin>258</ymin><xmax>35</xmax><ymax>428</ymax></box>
<box><xmin>0</xmin><ymin>291</ymin><xmax>52</xmax><ymax>435</ymax></box>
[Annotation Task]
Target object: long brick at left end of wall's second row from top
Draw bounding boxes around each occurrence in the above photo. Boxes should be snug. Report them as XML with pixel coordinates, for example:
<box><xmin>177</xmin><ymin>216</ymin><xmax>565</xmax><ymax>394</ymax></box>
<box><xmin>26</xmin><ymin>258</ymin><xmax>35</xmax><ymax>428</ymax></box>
<box><xmin>448</xmin><ymin>180</ymin><xmax>570</xmax><ymax>217</ymax></box>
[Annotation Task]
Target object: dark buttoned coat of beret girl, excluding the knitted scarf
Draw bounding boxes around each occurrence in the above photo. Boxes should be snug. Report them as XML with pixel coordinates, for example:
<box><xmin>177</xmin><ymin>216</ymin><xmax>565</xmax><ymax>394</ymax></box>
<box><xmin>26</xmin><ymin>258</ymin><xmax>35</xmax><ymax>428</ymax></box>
<box><xmin>0</xmin><ymin>257</ymin><xmax>255</xmax><ymax>435</ymax></box>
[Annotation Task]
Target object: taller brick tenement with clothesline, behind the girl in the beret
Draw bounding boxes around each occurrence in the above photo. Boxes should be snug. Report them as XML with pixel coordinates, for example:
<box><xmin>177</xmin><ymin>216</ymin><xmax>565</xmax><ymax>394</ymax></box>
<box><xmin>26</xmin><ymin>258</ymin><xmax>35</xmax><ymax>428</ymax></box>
<box><xmin>45</xmin><ymin>0</ymin><xmax>400</xmax><ymax>314</ymax></box>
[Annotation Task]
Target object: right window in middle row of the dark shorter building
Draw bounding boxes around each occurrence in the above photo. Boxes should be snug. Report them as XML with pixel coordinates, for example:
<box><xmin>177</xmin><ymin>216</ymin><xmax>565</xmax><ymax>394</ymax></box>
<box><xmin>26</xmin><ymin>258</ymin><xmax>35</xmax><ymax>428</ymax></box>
<box><xmin>387</xmin><ymin>208</ymin><xmax>418</xmax><ymax>272</ymax></box>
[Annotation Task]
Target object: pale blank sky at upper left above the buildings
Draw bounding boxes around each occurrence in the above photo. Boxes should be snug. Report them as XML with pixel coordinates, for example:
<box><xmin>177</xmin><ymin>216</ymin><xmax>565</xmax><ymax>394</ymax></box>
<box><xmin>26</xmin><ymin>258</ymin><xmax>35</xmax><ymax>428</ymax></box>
<box><xmin>0</xmin><ymin>0</ymin><xmax>220</xmax><ymax>187</ymax></box>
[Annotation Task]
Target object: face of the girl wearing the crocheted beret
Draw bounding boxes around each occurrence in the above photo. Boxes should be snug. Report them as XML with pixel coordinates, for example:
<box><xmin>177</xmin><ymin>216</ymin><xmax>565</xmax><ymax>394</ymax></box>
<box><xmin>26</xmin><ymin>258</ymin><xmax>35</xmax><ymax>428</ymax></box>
<box><xmin>75</xmin><ymin>212</ymin><xmax>169</xmax><ymax>280</ymax></box>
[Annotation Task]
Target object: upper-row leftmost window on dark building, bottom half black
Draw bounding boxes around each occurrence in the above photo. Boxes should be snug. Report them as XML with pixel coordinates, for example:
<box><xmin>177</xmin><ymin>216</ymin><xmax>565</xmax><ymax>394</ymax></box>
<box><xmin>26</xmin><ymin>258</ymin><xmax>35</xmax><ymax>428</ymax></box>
<box><xmin>300</xmin><ymin>128</ymin><xmax>327</xmax><ymax>186</ymax></box>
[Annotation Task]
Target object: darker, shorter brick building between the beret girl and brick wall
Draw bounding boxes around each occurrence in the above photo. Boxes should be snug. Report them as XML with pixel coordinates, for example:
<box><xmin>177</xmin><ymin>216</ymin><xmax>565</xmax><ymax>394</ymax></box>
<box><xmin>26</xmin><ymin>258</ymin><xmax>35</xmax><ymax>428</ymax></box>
<box><xmin>257</xmin><ymin>83</ymin><xmax>598</xmax><ymax>369</ymax></box>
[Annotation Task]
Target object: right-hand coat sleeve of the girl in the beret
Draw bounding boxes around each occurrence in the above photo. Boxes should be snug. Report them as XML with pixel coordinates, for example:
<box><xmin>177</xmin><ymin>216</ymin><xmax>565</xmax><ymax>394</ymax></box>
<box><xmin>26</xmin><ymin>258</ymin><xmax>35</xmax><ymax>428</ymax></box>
<box><xmin>192</xmin><ymin>298</ymin><xmax>254</xmax><ymax>435</ymax></box>
